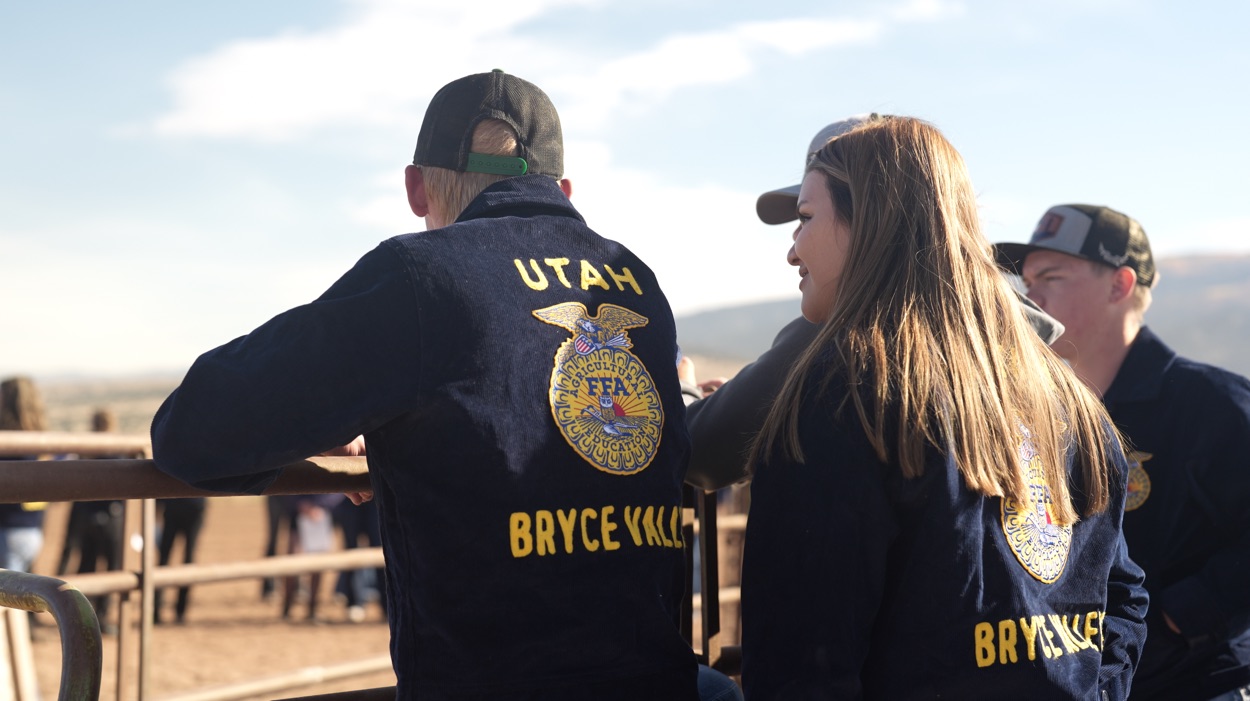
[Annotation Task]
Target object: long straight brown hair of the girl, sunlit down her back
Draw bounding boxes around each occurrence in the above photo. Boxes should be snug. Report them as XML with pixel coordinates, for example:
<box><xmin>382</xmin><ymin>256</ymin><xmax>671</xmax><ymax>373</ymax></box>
<box><xmin>751</xmin><ymin>117</ymin><xmax>1114</xmax><ymax>525</ymax></box>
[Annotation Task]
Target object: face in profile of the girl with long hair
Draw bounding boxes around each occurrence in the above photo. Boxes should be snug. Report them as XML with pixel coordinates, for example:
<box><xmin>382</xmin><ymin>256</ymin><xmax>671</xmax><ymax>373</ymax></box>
<box><xmin>786</xmin><ymin>171</ymin><xmax>851</xmax><ymax>324</ymax></box>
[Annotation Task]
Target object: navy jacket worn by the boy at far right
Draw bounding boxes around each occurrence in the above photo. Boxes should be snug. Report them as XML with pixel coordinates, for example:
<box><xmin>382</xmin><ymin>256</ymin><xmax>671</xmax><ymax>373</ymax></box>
<box><xmin>1104</xmin><ymin>327</ymin><xmax>1250</xmax><ymax>701</ymax></box>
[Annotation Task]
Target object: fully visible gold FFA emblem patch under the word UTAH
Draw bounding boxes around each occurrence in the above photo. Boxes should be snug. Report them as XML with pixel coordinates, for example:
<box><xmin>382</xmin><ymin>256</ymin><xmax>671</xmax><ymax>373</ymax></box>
<box><xmin>534</xmin><ymin>302</ymin><xmax>664</xmax><ymax>475</ymax></box>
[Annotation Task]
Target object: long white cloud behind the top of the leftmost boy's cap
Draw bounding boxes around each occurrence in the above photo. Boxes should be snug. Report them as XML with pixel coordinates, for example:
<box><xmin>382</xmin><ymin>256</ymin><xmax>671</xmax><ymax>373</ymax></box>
<box><xmin>148</xmin><ymin>0</ymin><xmax>885</xmax><ymax>141</ymax></box>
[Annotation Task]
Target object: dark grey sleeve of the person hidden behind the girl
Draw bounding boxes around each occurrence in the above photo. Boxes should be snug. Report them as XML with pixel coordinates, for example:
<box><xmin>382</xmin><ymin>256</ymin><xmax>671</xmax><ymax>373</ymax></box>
<box><xmin>686</xmin><ymin>317</ymin><xmax>820</xmax><ymax>491</ymax></box>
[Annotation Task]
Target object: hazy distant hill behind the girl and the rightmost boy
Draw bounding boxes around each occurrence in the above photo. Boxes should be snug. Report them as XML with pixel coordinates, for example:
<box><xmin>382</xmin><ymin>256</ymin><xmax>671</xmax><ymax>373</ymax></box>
<box><xmin>678</xmin><ymin>255</ymin><xmax>1250</xmax><ymax>376</ymax></box>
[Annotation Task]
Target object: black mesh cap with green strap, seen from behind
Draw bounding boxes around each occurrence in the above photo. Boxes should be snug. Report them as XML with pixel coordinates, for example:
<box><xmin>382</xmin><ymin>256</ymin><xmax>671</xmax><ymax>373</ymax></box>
<box><xmin>413</xmin><ymin>69</ymin><xmax>564</xmax><ymax>177</ymax></box>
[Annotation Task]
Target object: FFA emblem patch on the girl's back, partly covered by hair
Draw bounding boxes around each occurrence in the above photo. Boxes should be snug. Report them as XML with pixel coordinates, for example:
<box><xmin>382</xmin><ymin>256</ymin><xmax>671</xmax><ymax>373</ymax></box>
<box><xmin>1003</xmin><ymin>427</ymin><xmax>1073</xmax><ymax>584</ymax></box>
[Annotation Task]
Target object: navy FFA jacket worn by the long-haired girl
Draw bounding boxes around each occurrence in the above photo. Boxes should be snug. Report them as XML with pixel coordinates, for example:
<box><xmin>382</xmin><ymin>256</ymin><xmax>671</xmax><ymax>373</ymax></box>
<box><xmin>743</xmin><ymin>369</ymin><xmax>1146</xmax><ymax>701</ymax></box>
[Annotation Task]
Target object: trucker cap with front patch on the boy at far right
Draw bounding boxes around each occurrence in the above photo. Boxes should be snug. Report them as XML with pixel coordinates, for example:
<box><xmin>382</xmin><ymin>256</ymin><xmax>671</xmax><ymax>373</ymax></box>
<box><xmin>994</xmin><ymin>205</ymin><xmax>1156</xmax><ymax>287</ymax></box>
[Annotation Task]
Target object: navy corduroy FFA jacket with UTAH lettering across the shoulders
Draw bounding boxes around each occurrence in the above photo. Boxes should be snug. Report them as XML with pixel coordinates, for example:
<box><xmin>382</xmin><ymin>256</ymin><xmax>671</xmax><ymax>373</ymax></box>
<box><xmin>153</xmin><ymin>176</ymin><xmax>696</xmax><ymax>700</ymax></box>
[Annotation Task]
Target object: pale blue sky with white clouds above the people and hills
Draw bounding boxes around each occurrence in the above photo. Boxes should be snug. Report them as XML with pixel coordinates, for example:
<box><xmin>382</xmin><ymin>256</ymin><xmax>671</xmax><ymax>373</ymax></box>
<box><xmin>0</xmin><ymin>0</ymin><xmax>1250</xmax><ymax>377</ymax></box>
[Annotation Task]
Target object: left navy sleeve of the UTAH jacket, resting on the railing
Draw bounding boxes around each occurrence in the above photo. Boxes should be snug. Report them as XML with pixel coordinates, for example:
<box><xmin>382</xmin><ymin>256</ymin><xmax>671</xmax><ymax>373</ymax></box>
<box><xmin>151</xmin><ymin>244</ymin><xmax>420</xmax><ymax>494</ymax></box>
